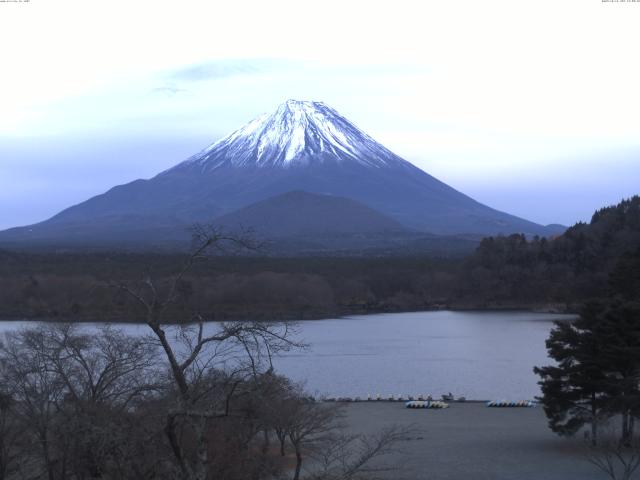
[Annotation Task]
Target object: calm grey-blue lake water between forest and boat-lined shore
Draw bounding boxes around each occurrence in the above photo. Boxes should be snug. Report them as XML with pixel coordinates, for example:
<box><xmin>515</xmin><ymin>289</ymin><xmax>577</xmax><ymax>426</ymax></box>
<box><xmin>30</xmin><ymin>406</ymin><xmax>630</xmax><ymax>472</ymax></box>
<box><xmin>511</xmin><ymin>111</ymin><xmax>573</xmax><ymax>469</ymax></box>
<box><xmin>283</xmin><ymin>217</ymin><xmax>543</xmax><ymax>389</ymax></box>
<box><xmin>0</xmin><ymin>311</ymin><xmax>572</xmax><ymax>400</ymax></box>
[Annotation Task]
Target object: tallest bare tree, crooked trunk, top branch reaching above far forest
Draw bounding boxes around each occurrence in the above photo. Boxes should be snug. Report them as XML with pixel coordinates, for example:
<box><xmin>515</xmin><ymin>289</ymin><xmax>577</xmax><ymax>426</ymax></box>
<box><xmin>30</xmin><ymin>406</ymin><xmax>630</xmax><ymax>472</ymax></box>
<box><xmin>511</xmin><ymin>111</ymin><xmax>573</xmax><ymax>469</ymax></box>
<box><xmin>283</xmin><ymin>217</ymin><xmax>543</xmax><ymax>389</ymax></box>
<box><xmin>110</xmin><ymin>226</ymin><xmax>296</xmax><ymax>480</ymax></box>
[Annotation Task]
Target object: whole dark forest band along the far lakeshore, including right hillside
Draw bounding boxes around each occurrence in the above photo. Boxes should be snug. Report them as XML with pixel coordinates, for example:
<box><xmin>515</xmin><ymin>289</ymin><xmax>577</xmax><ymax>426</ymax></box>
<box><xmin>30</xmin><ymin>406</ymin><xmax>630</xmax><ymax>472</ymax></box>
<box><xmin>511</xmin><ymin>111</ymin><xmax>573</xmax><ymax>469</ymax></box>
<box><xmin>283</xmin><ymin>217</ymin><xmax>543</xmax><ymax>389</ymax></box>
<box><xmin>0</xmin><ymin>196</ymin><xmax>640</xmax><ymax>321</ymax></box>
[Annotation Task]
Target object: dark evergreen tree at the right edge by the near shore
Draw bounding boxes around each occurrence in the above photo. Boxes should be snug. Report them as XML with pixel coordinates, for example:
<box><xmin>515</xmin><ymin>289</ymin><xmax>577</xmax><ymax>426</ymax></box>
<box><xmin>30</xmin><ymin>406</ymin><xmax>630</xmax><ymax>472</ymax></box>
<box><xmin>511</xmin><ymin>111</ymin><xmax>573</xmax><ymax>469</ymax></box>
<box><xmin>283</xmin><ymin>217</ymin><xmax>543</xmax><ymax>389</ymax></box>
<box><xmin>534</xmin><ymin>300</ymin><xmax>640</xmax><ymax>444</ymax></box>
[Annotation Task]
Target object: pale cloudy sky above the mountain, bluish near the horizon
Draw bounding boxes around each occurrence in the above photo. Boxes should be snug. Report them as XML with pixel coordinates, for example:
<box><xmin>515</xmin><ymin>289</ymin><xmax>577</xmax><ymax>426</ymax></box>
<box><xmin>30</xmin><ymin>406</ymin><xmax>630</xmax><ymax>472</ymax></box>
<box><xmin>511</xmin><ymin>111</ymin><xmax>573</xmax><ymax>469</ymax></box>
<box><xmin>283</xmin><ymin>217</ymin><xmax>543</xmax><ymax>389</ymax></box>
<box><xmin>0</xmin><ymin>0</ymin><xmax>640</xmax><ymax>229</ymax></box>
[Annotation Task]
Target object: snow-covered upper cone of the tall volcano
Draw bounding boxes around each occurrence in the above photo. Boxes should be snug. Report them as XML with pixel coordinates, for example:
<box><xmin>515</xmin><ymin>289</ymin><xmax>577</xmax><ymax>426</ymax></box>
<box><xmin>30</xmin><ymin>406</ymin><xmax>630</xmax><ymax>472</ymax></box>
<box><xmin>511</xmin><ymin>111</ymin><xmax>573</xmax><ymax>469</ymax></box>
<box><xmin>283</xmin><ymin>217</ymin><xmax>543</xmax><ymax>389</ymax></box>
<box><xmin>175</xmin><ymin>100</ymin><xmax>407</xmax><ymax>171</ymax></box>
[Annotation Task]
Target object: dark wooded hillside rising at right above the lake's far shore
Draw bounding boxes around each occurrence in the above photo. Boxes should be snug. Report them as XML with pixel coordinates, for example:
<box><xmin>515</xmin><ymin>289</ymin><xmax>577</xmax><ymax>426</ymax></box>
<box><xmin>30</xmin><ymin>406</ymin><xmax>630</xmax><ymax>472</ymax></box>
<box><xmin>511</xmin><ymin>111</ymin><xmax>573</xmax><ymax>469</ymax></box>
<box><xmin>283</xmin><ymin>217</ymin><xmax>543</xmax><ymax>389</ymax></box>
<box><xmin>454</xmin><ymin>196</ymin><xmax>640</xmax><ymax>305</ymax></box>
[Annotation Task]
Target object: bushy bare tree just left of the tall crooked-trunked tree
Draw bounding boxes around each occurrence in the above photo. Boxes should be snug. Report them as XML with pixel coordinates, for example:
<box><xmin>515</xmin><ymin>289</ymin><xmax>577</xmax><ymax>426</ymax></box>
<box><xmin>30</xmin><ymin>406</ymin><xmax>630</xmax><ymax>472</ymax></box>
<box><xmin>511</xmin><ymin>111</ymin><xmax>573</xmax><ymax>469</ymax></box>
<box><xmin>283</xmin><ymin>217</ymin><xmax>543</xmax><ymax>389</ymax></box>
<box><xmin>42</xmin><ymin>324</ymin><xmax>161</xmax><ymax>478</ymax></box>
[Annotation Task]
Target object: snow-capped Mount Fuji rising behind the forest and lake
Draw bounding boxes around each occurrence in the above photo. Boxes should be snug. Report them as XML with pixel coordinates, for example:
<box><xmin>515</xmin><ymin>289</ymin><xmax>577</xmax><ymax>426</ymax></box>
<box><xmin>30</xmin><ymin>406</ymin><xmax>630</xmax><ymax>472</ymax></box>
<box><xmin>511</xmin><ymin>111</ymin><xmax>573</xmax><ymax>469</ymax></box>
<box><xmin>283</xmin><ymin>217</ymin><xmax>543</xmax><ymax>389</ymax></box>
<box><xmin>0</xmin><ymin>100</ymin><xmax>563</xmax><ymax>251</ymax></box>
